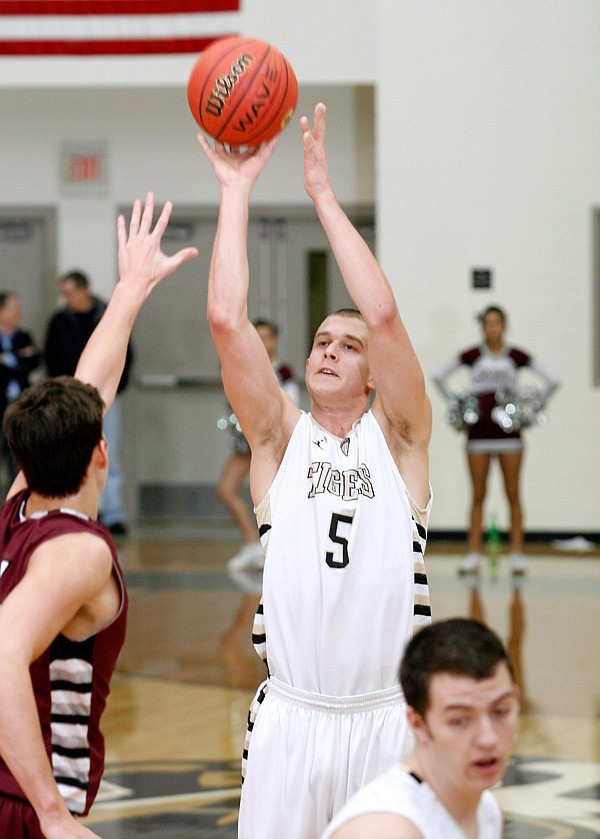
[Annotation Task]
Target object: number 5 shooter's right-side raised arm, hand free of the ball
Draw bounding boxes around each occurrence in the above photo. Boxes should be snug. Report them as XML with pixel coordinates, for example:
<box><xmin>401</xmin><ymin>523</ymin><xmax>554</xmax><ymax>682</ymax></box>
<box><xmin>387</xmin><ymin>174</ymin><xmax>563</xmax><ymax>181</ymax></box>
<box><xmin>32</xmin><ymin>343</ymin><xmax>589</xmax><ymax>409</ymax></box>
<box><xmin>300</xmin><ymin>109</ymin><xmax>431</xmax><ymax>496</ymax></box>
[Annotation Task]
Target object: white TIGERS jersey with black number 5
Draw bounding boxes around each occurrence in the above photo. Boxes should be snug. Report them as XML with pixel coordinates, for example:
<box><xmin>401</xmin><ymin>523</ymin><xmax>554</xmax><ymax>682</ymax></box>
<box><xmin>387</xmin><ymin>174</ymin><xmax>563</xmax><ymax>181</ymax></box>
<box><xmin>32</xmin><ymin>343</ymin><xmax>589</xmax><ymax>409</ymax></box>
<box><xmin>254</xmin><ymin>411</ymin><xmax>431</xmax><ymax>696</ymax></box>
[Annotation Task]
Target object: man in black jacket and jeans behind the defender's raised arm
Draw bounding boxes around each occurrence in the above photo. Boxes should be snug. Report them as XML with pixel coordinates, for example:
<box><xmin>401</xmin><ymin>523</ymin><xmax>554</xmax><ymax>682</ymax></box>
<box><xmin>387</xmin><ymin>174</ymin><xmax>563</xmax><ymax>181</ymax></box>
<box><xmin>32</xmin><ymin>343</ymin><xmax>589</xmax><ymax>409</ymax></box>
<box><xmin>44</xmin><ymin>271</ymin><xmax>133</xmax><ymax>536</ymax></box>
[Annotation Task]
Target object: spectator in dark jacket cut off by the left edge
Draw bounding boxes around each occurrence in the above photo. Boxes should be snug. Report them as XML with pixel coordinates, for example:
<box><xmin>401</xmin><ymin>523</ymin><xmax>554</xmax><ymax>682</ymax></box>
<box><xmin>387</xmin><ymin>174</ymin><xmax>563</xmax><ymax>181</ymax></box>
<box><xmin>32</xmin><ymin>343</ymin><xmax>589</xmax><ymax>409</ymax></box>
<box><xmin>0</xmin><ymin>291</ymin><xmax>42</xmax><ymax>494</ymax></box>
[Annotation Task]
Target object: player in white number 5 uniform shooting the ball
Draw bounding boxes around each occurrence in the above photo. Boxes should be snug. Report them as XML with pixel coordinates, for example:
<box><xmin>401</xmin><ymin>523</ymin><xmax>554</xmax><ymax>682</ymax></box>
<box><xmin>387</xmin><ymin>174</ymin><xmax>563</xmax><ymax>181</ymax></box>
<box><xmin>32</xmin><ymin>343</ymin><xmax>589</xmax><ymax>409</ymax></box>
<box><xmin>199</xmin><ymin>104</ymin><xmax>431</xmax><ymax>839</ymax></box>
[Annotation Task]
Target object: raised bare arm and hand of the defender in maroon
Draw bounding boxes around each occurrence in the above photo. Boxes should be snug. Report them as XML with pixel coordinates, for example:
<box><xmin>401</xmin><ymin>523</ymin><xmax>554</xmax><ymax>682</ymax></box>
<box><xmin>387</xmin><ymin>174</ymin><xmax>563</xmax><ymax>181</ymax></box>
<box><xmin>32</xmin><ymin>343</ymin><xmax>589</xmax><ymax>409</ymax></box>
<box><xmin>75</xmin><ymin>192</ymin><xmax>198</xmax><ymax>411</ymax></box>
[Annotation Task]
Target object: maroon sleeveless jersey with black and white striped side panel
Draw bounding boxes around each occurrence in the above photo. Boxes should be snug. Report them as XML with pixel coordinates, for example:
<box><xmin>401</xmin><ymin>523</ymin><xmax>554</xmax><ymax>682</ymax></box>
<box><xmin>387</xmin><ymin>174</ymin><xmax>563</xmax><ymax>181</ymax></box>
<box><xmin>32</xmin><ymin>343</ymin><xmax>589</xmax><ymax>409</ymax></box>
<box><xmin>0</xmin><ymin>491</ymin><xmax>127</xmax><ymax>815</ymax></box>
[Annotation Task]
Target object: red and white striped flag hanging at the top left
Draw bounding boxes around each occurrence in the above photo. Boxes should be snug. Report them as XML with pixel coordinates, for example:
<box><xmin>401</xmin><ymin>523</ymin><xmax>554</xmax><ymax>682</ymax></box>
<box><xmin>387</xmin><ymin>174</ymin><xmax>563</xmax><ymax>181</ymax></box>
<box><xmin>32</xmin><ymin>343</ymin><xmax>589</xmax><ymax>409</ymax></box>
<box><xmin>0</xmin><ymin>0</ymin><xmax>241</xmax><ymax>55</ymax></box>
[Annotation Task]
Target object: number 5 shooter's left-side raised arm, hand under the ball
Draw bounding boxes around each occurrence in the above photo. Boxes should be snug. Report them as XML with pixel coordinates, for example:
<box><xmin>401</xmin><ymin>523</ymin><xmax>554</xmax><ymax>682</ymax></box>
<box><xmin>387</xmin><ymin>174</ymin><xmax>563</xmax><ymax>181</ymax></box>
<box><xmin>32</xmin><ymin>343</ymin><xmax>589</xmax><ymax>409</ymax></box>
<box><xmin>198</xmin><ymin>135</ymin><xmax>297</xmax><ymax>460</ymax></box>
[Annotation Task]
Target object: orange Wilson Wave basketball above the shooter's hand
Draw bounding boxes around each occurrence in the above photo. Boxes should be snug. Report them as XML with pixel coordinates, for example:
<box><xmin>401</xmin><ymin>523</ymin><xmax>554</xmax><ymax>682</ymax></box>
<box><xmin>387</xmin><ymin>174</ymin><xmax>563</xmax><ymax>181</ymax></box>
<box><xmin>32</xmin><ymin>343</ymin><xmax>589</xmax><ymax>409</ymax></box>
<box><xmin>187</xmin><ymin>36</ymin><xmax>298</xmax><ymax>146</ymax></box>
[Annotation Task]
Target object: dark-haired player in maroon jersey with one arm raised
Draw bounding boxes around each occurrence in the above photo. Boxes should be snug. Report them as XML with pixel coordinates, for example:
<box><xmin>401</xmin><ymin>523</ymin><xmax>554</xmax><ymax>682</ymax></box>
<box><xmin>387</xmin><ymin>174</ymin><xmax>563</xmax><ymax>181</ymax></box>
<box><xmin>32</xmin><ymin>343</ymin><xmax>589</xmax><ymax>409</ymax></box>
<box><xmin>0</xmin><ymin>194</ymin><xmax>197</xmax><ymax>839</ymax></box>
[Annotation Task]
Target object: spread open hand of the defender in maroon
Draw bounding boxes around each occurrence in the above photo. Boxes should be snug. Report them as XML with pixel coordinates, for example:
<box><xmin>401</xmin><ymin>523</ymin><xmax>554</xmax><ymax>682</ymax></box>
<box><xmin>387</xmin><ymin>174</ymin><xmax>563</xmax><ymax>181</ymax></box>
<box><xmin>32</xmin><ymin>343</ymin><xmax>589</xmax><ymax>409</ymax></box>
<box><xmin>117</xmin><ymin>192</ymin><xmax>198</xmax><ymax>297</ymax></box>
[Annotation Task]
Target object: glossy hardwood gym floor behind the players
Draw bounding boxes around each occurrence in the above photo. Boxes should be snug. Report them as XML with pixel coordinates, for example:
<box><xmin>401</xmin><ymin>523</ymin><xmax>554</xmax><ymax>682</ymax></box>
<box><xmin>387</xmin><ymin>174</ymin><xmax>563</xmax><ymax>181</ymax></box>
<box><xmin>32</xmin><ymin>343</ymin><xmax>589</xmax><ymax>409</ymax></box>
<box><xmin>79</xmin><ymin>528</ymin><xmax>600</xmax><ymax>839</ymax></box>
